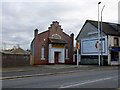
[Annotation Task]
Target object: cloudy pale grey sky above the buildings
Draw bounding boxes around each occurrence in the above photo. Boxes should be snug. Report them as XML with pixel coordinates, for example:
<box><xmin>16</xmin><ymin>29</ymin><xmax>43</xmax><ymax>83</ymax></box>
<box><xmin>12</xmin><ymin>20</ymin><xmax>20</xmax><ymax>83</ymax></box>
<box><xmin>0</xmin><ymin>0</ymin><xmax>119</xmax><ymax>49</ymax></box>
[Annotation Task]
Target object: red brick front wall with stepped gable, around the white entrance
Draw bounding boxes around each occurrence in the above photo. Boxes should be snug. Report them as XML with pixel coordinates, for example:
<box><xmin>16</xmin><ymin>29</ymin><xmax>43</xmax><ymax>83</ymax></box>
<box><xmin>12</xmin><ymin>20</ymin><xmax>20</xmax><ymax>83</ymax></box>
<box><xmin>34</xmin><ymin>21</ymin><xmax>74</xmax><ymax>64</ymax></box>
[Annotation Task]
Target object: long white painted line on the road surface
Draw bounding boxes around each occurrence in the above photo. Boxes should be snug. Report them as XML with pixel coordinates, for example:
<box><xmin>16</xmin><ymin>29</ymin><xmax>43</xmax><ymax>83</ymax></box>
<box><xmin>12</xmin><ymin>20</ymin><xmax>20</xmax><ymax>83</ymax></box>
<box><xmin>59</xmin><ymin>77</ymin><xmax>115</xmax><ymax>88</ymax></box>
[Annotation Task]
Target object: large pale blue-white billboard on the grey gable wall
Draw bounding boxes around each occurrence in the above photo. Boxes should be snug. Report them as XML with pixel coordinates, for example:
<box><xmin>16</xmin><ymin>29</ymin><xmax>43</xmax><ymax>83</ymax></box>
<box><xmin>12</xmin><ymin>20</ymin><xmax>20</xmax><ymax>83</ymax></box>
<box><xmin>81</xmin><ymin>37</ymin><xmax>107</xmax><ymax>55</ymax></box>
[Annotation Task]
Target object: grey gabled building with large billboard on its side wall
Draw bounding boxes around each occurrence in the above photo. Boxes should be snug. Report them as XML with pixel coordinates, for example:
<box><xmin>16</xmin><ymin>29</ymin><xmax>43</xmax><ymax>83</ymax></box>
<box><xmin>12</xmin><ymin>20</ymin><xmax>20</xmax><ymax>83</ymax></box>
<box><xmin>76</xmin><ymin>20</ymin><xmax>120</xmax><ymax>65</ymax></box>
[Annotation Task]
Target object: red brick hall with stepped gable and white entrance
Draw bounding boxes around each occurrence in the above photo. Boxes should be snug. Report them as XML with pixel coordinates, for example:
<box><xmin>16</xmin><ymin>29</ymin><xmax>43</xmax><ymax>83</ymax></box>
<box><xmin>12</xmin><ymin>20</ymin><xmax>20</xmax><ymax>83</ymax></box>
<box><xmin>31</xmin><ymin>21</ymin><xmax>74</xmax><ymax>65</ymax></box>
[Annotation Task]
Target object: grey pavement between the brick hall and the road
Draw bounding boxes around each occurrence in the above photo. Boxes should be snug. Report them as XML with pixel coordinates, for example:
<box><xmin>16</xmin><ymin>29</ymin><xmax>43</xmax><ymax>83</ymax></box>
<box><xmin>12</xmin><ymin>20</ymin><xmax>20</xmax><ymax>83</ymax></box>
<box><xmin>0</xmin><ymin>65</ymin><xmax>118</xmax><ymax>80</ymax></box>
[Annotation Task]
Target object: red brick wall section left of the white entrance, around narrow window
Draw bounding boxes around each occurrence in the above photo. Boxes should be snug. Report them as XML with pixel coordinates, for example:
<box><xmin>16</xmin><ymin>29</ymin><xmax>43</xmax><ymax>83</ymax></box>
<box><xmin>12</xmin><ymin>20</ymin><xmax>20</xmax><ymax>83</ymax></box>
<box><xmin>34</xmin><ymin>31</ymin><xmax>48</xmax><ymax>64</ymax></box>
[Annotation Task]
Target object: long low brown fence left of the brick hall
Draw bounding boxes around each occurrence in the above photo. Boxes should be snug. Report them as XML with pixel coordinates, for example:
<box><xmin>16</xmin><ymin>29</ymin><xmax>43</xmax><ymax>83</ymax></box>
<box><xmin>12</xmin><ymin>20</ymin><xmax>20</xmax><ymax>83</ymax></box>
<box><xmin>2</xmin><ymin>53</ymin><xmax>30</xmax><ymax>67</ymax></box>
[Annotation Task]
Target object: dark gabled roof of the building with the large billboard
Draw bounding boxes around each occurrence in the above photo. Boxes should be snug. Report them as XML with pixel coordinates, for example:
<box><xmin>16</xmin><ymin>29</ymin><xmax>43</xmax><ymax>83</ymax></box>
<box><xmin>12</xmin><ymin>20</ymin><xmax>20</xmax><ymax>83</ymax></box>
<box><xmin>76</xmin><ymin>20</ymin><xmax>120</xmax><ymax>39</ymax></box>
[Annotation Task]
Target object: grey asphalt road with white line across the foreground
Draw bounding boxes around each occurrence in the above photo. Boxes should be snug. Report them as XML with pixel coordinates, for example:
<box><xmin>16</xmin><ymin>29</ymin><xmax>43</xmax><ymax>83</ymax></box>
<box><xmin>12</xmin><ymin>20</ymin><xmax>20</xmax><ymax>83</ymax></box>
<box><xmin>2</xmin><ymin>68</ymin><xmax>120</xmax><ymax>89</ymax></box>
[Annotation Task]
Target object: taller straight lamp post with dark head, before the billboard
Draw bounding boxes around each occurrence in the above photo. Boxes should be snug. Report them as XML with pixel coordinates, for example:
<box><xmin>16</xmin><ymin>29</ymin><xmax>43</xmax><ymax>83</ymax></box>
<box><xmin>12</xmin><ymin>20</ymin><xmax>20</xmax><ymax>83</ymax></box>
<box><xmin>98</xmin><ymin>2</ymin><xmax>101</xmax><ymax>66</ymax></box>
